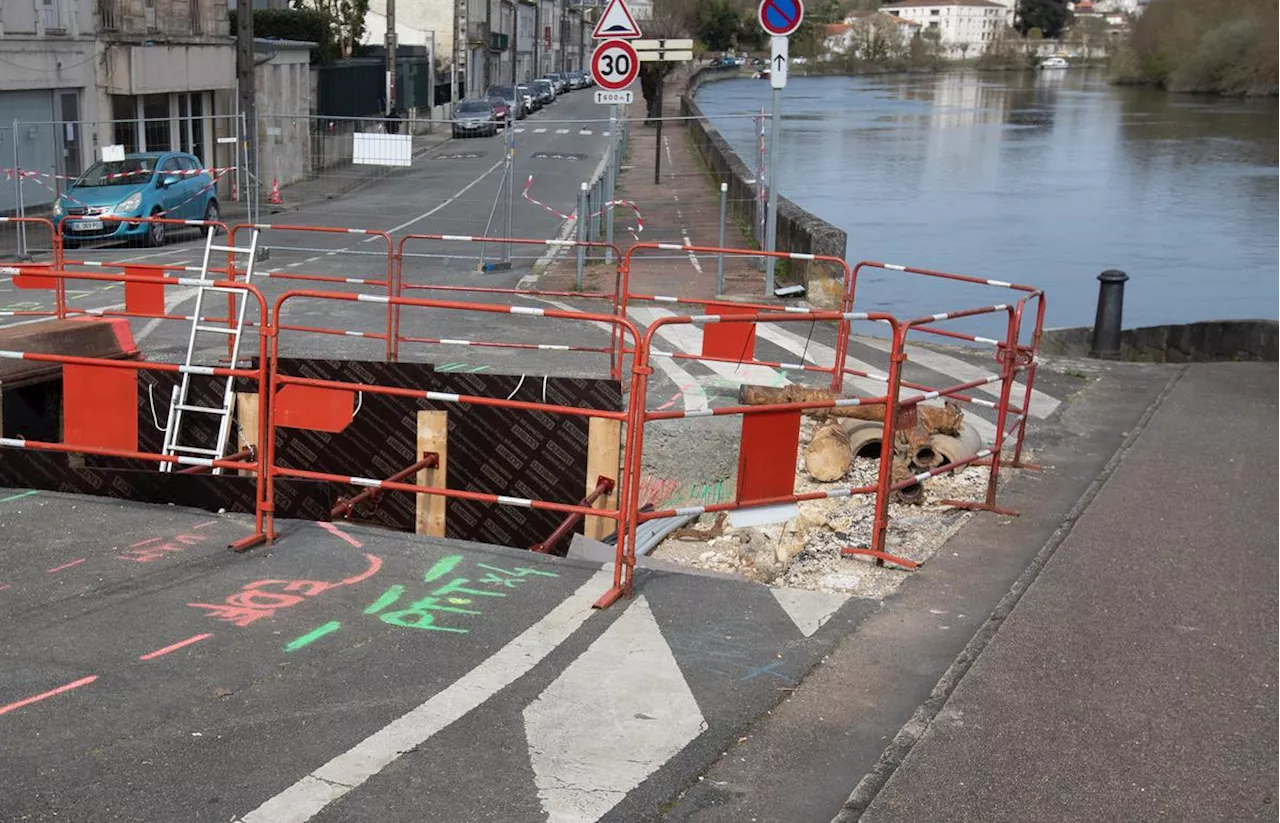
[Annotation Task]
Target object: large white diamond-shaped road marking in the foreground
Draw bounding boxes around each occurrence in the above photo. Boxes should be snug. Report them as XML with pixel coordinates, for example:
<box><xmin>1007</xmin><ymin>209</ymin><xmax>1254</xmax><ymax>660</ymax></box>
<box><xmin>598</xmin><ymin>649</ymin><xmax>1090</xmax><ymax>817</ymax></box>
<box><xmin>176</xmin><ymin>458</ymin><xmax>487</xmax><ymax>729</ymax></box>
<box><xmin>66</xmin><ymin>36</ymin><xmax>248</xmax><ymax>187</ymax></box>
<box><xmin>525</xmin><ymin>596</ymin><xmax>707</xmax><ymax>823</ymax></box>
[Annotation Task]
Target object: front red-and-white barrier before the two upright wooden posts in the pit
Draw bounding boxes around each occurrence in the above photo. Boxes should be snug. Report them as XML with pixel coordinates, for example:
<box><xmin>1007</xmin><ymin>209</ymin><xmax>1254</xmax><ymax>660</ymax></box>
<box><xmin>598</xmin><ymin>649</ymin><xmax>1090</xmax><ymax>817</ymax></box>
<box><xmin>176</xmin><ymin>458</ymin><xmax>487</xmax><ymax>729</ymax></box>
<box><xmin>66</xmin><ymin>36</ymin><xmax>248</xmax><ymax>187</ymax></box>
<box><xmin>265</xmin><ymin>289</ymin><xmax>643</xmax><ymax>608</ymax></box>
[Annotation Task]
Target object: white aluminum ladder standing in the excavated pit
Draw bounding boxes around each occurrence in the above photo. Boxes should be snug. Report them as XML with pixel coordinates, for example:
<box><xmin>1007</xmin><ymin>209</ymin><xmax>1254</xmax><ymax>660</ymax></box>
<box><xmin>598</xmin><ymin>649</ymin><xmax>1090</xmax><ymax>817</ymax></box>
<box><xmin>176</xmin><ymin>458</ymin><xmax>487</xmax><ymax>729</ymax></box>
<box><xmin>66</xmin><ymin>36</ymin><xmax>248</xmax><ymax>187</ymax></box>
<box><xmin>160</xmin><ymin>227</ymin><xmax>262</xmax><ymax>475</ymax></box>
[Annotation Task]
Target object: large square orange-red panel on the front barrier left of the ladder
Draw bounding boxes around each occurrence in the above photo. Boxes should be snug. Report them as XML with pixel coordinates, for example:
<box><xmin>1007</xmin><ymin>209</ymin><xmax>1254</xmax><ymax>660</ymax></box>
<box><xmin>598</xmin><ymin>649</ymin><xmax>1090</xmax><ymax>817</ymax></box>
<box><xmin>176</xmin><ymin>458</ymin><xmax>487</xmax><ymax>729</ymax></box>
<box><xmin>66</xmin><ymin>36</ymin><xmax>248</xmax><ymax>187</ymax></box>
<box><xmin>63</xmin><ymin>365</ymin><xmax>138</xmax><ymax>452</ymax></box>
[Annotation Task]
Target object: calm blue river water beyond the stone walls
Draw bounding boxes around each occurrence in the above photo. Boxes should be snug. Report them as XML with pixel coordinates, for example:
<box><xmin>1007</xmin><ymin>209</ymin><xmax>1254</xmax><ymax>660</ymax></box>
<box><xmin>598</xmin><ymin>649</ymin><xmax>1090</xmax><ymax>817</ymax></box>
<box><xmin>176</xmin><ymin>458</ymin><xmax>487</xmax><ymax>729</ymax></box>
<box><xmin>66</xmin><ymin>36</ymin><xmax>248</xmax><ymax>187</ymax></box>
<box><xmin>698</xmin><ymin>69</ymin><xmax>1280</xmax><ymax>328</ymax></box>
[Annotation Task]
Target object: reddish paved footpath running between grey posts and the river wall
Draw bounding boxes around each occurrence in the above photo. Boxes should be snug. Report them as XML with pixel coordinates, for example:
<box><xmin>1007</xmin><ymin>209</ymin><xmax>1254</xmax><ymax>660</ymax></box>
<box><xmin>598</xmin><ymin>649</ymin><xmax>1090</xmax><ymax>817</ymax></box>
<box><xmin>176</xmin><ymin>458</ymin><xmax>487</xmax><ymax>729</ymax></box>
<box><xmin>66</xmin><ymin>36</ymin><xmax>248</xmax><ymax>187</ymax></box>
<box><xmin>538</xmin><ymin>73</ymin><xmax>764</xmax><ymax>298</ymax></box>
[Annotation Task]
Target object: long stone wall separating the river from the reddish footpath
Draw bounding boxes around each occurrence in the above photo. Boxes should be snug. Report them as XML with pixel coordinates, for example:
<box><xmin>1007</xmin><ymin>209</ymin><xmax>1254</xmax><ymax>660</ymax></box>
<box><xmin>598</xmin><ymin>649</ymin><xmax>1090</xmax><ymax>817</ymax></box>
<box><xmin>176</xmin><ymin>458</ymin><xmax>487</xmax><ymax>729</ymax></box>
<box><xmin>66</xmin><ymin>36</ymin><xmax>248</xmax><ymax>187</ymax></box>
<box><xmin>680</xmin><ymin>68</ymin><xmax>849</xmax><ymax>305</ymax></box>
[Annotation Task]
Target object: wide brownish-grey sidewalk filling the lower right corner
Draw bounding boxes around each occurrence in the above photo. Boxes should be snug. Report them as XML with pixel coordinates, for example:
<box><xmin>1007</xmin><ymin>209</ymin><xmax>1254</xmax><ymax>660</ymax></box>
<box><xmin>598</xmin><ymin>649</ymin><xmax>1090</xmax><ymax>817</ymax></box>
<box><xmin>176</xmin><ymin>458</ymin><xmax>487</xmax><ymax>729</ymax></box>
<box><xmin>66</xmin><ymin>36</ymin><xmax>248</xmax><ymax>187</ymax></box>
<box><xmin>840</xmin><ymin>364</ymin><xmax>1280</xmax><ymax>823</ymax></box>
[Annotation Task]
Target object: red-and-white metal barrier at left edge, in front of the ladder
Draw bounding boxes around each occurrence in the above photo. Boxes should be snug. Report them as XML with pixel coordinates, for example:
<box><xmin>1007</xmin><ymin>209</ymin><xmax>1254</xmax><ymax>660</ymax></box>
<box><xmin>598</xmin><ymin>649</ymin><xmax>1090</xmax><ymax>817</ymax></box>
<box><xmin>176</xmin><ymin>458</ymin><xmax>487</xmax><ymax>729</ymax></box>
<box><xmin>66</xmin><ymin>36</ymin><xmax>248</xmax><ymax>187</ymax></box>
<box><xmin>0</xmin><ymin>266</ymin><xmax>269</xmax><ymax>549</ymax></box>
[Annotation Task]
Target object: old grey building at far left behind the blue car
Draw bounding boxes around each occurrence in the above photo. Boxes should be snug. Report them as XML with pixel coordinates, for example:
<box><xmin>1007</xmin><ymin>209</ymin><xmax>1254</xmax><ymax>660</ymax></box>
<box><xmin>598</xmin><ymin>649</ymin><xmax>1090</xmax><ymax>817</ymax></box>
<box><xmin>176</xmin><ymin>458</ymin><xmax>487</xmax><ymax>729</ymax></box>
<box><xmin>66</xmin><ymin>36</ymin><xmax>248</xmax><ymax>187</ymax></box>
<box><xmin>0</xmin><ymin>0</ymin><xmax>236</xmax><ymax>212</ymax></box>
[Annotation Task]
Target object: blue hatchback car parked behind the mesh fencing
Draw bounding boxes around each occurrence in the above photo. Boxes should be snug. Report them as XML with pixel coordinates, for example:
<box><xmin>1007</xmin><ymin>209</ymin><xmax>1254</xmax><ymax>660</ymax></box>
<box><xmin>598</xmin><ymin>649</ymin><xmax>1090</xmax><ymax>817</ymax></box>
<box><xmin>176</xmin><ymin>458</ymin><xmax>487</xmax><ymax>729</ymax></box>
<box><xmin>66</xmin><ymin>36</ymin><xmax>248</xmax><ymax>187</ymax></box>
<box><xmin>54</xmin><ymin>151</ymin><xmax>218</xmax><ymax>246</ymax></box>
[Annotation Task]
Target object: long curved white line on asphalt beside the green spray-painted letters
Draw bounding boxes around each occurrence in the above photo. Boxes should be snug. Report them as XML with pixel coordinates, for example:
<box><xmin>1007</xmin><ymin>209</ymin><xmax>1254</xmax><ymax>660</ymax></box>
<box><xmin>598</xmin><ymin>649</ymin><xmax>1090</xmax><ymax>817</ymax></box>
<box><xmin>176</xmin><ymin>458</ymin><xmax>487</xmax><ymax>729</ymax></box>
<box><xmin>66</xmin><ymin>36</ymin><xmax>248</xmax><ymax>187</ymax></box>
<box><xmin>239</xmin><ymin>567</ymin><xmax>621</xmax><ymax>823</ymax></box>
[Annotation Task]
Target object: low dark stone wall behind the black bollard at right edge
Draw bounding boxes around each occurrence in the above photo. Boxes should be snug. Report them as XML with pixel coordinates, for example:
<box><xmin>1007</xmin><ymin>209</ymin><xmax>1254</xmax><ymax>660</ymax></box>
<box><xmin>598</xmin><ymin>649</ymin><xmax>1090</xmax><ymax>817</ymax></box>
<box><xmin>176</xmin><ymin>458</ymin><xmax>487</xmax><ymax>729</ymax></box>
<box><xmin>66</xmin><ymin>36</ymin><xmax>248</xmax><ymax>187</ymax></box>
<box><xmin>1041</xmin><ymin>320</ymin><xmax>1280</xmax><ymax>364</ymax></box>
